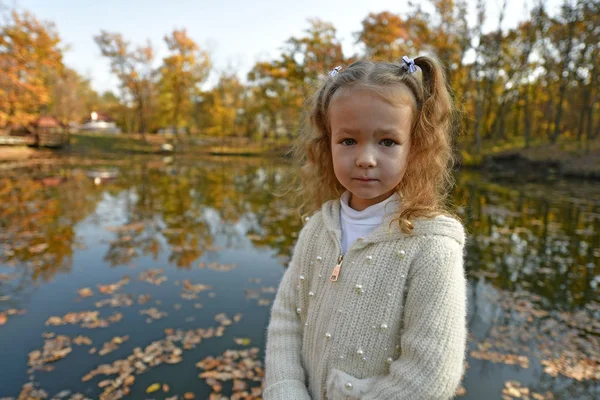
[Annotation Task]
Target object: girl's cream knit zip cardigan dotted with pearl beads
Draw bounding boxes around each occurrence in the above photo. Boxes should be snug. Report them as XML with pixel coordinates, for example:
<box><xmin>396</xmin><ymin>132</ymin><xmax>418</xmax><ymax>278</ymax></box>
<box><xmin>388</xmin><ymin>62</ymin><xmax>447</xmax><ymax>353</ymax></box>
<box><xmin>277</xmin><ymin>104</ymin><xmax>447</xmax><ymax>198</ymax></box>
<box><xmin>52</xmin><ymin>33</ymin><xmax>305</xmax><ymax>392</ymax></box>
<box><xmin>263</xmin><ymin>200</ymin><xmax>467</xmax><ymax>400</ymax></box>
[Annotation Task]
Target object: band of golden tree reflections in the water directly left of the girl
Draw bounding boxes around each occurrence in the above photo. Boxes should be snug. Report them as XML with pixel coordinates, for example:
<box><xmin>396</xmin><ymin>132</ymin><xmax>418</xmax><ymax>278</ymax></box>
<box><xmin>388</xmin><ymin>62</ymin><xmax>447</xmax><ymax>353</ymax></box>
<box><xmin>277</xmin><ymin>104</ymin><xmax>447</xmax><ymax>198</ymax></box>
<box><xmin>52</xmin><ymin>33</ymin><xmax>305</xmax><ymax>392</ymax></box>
<box><xmin>92</xmin><ymin>159</ymin><xmax>301</xmax><ymax>267</ymax></box>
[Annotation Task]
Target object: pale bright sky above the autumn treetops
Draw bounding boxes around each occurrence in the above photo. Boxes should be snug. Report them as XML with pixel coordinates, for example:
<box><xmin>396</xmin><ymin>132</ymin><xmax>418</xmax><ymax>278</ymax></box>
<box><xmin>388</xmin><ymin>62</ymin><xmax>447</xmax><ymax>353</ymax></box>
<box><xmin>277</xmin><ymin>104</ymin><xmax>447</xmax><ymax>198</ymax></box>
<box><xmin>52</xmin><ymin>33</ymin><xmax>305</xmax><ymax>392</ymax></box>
<box><xmin>10</xmin><ymin>0</ymin><xmax>560</xmax><ymax>92</ymax></box>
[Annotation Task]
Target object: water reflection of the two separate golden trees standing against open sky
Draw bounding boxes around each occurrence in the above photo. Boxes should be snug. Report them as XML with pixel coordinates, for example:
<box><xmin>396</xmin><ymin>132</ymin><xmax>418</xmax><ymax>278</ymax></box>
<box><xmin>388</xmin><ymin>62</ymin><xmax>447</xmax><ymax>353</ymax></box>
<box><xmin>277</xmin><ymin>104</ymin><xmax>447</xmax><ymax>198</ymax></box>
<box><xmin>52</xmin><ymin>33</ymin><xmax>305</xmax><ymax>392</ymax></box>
<box><xmin>105</xmin><ymin>163</ymin><xmax>212</xmax><ymax>267</ymax></box>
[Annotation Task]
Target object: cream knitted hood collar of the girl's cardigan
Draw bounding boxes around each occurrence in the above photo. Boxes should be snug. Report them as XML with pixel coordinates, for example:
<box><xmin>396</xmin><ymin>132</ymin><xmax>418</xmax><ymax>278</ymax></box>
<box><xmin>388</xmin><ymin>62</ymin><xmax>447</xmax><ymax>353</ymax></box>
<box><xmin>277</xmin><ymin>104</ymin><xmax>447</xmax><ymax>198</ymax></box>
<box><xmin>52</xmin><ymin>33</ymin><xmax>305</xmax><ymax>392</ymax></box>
<box><xmin>321</xmin><ymin>199</ymin><xmax>465</xmax><ymax>247</ymax></box>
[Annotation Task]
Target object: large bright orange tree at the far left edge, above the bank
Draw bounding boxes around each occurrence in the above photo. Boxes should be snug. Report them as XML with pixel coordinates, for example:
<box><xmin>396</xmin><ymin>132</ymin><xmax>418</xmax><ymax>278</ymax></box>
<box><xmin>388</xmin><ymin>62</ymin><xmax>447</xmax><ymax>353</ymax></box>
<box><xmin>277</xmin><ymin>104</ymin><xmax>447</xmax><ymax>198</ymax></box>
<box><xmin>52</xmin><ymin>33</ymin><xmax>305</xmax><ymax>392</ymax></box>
<box><xmin>0</xmin><ymin>11</ymin><xmax>63</xmax><ymax>127</ymax></box>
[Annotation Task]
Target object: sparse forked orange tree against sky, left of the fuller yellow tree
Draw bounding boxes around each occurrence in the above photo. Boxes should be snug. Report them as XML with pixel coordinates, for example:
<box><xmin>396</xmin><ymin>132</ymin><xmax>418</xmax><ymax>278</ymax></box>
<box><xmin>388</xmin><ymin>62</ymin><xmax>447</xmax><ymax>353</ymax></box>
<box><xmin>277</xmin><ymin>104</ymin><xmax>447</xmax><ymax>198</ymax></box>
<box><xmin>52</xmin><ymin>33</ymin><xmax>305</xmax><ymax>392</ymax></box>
<box><xmin>94</xmin><ymin>31</ymin><xmax>156</xmax><ymax>135</ymax></box>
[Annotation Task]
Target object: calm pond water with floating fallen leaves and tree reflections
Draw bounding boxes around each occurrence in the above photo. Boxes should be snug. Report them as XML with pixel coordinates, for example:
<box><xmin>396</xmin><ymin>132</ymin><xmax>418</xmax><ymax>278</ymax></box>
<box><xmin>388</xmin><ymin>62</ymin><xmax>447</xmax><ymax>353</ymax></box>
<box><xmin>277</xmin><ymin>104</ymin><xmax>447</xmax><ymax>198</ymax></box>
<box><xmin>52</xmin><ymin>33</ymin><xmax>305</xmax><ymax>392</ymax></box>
<box><xmin>0</xmin><ymin>158</ymin><xmax>600</xmax><ymax>400</ymax></box>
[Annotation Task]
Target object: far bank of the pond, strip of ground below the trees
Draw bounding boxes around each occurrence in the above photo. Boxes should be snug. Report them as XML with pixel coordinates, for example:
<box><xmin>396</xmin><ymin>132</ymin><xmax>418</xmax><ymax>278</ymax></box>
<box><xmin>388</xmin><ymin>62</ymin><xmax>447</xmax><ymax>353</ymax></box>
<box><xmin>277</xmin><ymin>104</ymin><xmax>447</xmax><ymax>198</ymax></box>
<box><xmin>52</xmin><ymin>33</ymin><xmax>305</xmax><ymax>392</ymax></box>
<box><xmin>0</xmin><ymin>134</ymin><xmax>600</xmax><ymax>181</ymax></box>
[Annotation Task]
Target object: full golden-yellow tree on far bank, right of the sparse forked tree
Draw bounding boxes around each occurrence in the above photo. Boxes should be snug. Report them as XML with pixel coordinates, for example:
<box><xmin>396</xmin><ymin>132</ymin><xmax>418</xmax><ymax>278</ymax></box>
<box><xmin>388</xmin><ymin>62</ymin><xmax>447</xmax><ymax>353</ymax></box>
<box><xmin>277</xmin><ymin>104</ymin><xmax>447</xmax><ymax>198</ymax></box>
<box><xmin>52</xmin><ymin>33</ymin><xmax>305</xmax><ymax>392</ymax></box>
<box><xmin>159</xmin><ymin>29</ymin><xmax>211</xmax><ymax>133</ymax></box>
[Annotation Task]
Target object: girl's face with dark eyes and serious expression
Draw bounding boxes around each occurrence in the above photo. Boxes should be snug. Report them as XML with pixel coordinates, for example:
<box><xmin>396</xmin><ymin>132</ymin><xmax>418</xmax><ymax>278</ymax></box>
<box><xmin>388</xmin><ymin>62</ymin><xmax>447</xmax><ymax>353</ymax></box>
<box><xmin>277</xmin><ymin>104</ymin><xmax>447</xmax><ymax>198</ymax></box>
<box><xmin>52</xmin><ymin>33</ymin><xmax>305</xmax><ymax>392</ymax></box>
<box><xmin>329</xmin><ymin>85</ymin><xmax>414</xmax><ymax>211</ymax></box>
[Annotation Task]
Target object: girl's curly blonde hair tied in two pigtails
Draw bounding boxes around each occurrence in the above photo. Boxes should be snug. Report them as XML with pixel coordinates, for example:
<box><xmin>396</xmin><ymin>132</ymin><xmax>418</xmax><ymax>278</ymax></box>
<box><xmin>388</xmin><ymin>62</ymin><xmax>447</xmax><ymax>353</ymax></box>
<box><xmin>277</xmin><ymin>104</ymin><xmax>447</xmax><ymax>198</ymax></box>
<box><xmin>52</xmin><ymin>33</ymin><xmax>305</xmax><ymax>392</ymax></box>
<box><xmin>292</xmin><ymin>56</ymin><xmax>455</xmax><ymax>233</ymax></box>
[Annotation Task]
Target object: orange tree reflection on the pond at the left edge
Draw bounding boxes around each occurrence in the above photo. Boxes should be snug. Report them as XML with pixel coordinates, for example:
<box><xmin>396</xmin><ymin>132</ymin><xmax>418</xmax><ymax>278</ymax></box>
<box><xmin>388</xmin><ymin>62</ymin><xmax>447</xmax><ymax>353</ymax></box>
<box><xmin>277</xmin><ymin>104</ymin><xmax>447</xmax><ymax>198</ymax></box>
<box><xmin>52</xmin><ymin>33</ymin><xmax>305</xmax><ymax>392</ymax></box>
<box><xmin>0</xmin><ymin>169</ymin><xmax>99</xmax><ymax>280</ymax></box>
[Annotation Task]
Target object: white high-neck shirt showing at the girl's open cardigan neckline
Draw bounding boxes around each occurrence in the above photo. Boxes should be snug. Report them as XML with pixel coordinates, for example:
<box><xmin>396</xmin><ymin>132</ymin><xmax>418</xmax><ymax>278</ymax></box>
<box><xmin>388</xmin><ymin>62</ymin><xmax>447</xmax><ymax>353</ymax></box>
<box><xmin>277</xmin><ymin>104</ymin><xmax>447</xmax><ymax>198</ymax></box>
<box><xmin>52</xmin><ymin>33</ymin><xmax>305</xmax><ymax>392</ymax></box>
<box><xmin>340</xmin><ymin>190</ymin><xmax>400</xmax><ymax>254</ymax></box>
